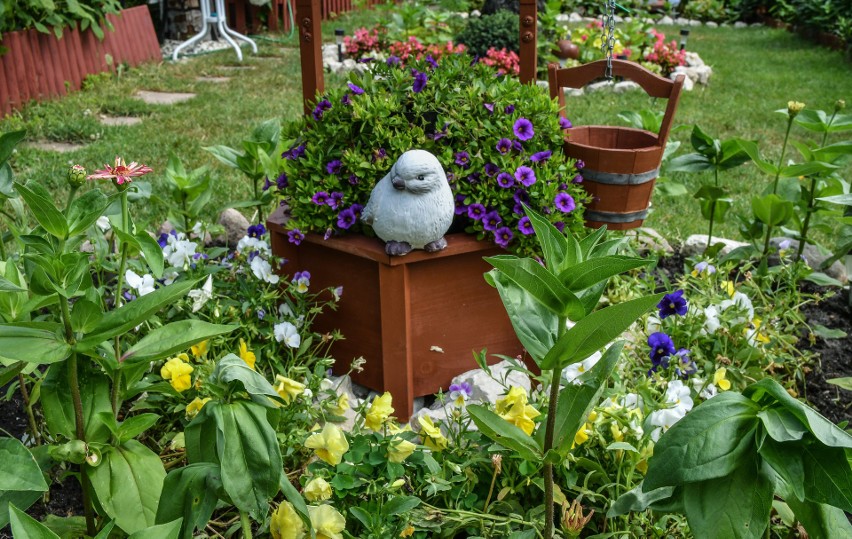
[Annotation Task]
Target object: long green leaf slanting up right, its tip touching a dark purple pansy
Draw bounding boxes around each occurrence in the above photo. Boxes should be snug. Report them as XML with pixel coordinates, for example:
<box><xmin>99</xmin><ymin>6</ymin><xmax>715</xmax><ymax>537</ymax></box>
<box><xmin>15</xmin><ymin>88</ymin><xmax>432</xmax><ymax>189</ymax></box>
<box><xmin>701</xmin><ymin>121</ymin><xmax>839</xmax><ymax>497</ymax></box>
<box><xmin>540</xmin><ymin>294</ymin><xmax>664</xmax><ymax>371</ymax></box>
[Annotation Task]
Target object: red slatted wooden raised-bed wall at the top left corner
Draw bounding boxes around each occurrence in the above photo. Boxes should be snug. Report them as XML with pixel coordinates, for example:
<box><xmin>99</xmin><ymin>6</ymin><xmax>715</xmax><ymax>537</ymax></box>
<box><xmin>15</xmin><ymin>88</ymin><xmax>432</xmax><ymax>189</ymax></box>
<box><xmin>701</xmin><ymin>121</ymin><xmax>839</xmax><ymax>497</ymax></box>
<box><xmin>0</xmin><ymin>5</ymin><xmax>161</xmax><ymax>116</ymax></box>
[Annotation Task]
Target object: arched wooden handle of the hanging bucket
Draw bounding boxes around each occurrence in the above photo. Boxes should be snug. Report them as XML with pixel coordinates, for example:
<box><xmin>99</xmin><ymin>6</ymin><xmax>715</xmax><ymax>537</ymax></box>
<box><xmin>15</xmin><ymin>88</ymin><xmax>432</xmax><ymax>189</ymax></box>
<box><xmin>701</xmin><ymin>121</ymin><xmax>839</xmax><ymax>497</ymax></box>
<box><xmin>547</xmin><ymin>58</ymin><xmax>684</xmax><ymax>150</ymax></box>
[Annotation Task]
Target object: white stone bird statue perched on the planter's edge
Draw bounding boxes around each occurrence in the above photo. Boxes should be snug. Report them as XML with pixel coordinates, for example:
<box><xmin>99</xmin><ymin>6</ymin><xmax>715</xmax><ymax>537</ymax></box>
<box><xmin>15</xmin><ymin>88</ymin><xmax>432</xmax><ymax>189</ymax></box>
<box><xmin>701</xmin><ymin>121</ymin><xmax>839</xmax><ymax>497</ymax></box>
<box><xmin>361</xmin><ymin>150</ymin><xmax>455</xmax><ymax>256</ymax></box>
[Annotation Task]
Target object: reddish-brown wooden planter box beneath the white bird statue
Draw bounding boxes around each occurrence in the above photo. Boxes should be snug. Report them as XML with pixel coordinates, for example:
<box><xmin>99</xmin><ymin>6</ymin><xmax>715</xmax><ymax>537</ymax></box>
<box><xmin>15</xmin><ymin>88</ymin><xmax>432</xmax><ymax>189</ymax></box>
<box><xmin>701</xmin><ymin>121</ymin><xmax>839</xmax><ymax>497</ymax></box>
<box><xmin>267</xmin><ymin>210</ymin><xmax>522</xmax><ymax>421</ymax></box>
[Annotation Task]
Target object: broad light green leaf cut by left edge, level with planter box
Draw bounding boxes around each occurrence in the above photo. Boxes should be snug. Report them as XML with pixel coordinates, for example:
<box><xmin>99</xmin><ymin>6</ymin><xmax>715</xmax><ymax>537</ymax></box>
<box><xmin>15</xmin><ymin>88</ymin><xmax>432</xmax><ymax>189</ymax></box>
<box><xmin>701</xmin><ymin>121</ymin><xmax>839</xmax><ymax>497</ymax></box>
<box><xmin>0</xmin><ymin>322</ymin><xmax>71</xmax><ymax>365</ymax></box>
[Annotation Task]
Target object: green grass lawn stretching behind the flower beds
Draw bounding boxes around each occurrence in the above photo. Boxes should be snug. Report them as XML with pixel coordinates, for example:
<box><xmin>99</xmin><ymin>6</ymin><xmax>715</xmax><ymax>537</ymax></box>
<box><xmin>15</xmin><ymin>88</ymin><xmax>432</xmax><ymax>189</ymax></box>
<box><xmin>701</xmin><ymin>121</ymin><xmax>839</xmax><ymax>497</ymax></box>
<box><xmin>0</xmin><ymin>13</ymin><xmax>852</xmax><ymax>244</ymax></box>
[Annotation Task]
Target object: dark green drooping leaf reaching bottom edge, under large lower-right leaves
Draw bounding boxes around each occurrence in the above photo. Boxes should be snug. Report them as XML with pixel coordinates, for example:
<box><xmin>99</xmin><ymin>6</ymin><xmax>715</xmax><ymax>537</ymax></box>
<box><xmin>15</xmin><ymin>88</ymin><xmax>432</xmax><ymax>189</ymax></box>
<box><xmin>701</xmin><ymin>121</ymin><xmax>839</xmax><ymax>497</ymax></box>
<box><xmin>684</xmin><ymin>460</ymin><xmax>774</xmax><ymax>539</ymax></box>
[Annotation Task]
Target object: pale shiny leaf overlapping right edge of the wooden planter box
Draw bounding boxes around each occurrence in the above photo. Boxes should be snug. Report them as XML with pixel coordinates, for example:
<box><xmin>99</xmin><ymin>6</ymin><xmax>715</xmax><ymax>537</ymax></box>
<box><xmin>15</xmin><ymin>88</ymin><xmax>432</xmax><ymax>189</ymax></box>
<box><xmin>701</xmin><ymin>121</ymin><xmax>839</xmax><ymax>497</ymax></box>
<box><xmin>485</xmin><ymin>270</ymin><xmax>559</xmax><ymax>364</ymax></box>
